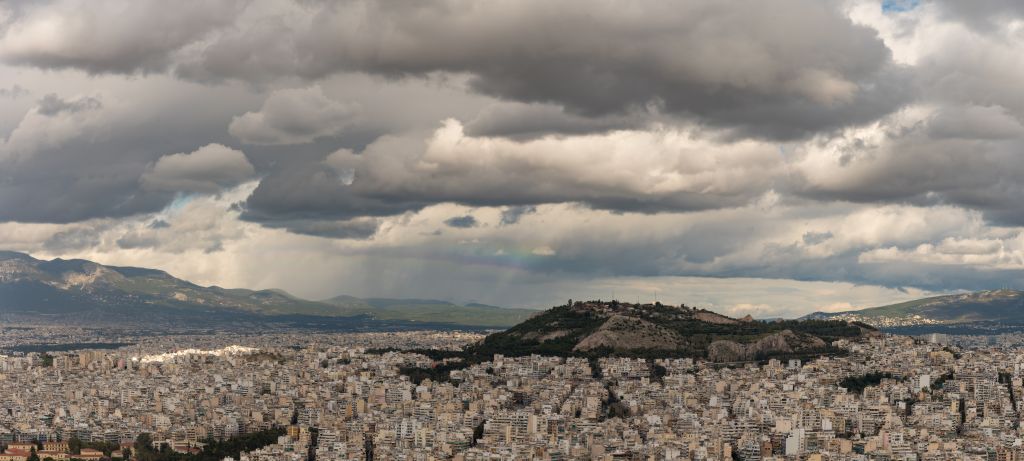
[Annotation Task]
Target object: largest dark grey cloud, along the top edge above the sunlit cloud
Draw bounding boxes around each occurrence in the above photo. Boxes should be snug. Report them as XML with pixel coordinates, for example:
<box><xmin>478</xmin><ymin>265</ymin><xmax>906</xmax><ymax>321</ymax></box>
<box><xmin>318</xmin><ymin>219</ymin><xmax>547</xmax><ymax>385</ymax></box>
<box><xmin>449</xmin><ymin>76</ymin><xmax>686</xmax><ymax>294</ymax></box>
<box><xmin>195</xmin><ymin>0</ymin><xmax>907</xmax><ymax>138</ymax></box>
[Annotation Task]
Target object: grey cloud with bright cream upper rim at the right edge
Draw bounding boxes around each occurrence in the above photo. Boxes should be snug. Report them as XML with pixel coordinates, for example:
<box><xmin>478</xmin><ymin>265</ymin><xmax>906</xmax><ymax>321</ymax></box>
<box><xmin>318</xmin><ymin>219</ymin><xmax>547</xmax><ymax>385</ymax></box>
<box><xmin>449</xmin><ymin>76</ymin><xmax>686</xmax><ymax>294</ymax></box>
<box><xmin>791</xmin><ymin>107</ymin><xmax>1024</xmax><ymax>224</ymax></box>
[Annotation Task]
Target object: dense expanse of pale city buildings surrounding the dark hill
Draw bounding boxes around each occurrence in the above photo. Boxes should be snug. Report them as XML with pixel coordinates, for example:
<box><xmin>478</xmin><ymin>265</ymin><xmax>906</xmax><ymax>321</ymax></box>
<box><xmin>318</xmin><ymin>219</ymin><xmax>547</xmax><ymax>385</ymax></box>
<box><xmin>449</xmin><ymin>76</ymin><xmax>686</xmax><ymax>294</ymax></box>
<box><xmin>0</xmin><ymin>330</ymin><xmax>1024</xmax><ymax>461</ymax></box>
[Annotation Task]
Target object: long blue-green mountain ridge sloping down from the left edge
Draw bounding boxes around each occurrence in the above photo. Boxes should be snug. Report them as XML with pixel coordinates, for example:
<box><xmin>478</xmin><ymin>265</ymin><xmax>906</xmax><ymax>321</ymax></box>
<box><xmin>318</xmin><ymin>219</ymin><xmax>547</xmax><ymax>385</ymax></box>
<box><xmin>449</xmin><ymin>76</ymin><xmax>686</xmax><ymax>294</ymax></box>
<box><xmin>0</xmin><ymin>251</ymin><xmax>536</xmax><ymax>327</ymax></box>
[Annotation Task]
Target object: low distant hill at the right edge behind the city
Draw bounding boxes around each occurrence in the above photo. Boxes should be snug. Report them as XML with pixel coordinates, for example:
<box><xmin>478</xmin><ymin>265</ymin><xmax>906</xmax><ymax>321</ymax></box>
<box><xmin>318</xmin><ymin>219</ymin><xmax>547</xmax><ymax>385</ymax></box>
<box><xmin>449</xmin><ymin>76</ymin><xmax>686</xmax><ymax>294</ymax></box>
<box><xmin>806</xmin><ymin>290</ymin><xmax>1024</xmax><ymax>327</ymax></box>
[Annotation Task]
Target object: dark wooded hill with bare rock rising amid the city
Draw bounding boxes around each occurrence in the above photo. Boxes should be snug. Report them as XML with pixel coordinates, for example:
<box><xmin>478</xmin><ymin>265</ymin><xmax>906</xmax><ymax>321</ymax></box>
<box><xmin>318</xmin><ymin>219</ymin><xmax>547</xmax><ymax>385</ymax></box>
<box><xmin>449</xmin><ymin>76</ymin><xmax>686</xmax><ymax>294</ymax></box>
<box><xmin>467</xmin><ymin>301</ymin><xmax>873</xmax><ymax>362</ymax></box>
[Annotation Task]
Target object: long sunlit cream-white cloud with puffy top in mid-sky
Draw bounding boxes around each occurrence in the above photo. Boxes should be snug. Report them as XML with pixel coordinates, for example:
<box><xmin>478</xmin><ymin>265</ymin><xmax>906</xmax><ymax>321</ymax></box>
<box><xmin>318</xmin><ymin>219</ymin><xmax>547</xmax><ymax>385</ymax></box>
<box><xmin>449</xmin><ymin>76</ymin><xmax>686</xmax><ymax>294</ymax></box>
<box><xmin>326</xmin><ymin>119</ymin><xmax>784</xmax><ymax>210</ymax></box>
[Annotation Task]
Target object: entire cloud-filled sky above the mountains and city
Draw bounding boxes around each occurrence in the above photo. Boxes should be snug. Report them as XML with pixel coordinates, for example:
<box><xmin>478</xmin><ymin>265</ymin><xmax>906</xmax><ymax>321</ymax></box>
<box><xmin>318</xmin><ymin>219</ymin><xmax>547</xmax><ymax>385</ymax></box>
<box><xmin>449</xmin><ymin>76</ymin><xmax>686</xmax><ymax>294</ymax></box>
<box><xmin>0</xmin><ymin>0</ymin><xmax>1024</xmax><ymax>318</ymax></box>
